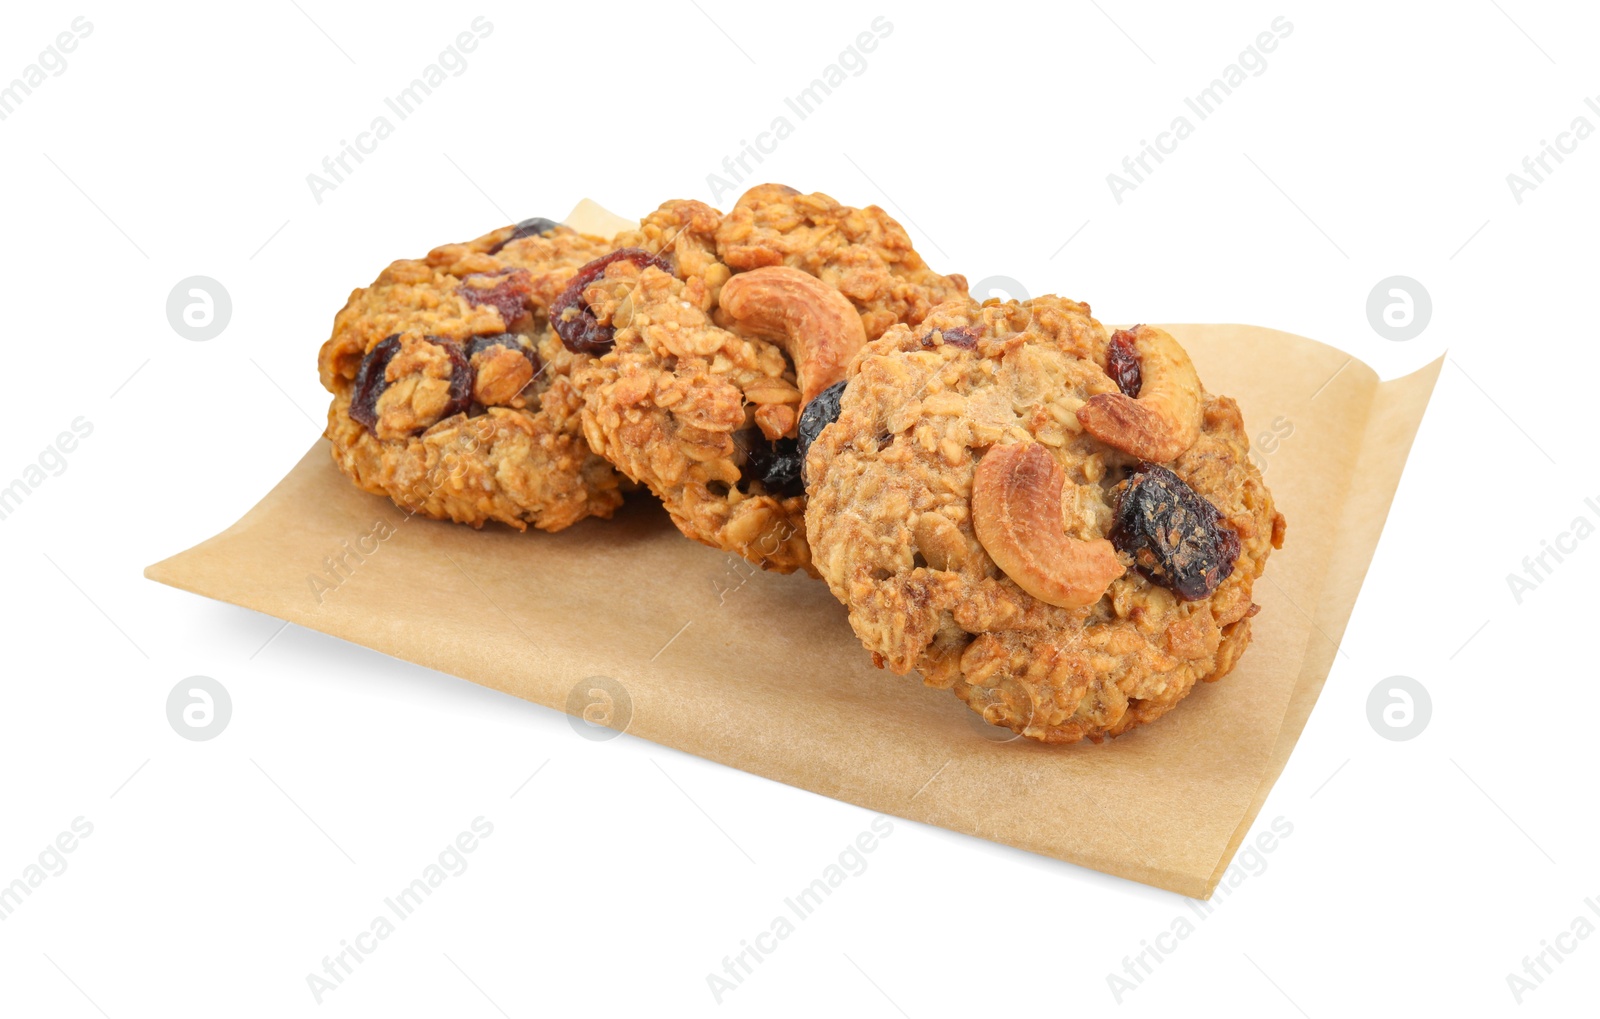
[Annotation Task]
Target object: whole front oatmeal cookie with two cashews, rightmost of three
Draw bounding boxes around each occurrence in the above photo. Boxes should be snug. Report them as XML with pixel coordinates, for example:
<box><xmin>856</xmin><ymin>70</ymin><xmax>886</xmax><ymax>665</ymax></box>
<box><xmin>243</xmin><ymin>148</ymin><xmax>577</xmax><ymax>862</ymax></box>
<box><xmin>805</xmin><ymin>296</ymin><xmax>1283</xmax><ymax>742</ymax></box>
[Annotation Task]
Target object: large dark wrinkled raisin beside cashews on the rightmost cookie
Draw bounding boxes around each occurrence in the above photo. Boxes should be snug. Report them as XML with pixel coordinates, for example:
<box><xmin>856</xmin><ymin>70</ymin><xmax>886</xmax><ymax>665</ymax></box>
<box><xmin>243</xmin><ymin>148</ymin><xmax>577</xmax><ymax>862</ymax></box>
<box><xmin>1110</xmin><ymin>464</ymin><xmax>1238</xmax><ymax>601</ymax></box>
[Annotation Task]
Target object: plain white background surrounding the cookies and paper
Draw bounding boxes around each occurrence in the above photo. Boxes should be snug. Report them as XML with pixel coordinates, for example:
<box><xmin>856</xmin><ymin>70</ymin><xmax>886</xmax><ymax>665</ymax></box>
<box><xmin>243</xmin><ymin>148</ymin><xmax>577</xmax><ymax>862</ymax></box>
<box><xmin>0</xmin><ymin>0</ymin><xmax>1600</xmax><ymax>1019</ymax></box>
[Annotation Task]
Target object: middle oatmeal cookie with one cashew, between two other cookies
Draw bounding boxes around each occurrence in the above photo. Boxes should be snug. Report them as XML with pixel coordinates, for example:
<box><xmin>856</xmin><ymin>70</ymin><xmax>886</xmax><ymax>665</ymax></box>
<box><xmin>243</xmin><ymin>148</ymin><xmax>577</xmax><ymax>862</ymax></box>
<box><xmin>572</xmin><ymin>184</ymin><xmax>966</xmax><ymax>573</ymax></box>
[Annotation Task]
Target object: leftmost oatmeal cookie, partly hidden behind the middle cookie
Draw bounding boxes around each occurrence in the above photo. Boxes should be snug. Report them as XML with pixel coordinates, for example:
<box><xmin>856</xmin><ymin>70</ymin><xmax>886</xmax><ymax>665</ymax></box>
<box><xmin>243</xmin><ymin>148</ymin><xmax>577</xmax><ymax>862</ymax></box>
<box><xmin>318</xmin><ymin>219</ymin><xmax>622</xmax><ymax>531</ymax></box>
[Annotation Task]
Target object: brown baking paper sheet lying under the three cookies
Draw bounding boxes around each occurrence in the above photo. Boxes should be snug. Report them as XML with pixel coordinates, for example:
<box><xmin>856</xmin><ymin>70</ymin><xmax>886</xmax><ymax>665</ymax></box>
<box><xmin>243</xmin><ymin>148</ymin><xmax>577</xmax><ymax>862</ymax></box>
<box><xmin>146</xmin><ymin>206</ymin><xmax>1443</xmax><ymax>897</ymax></box>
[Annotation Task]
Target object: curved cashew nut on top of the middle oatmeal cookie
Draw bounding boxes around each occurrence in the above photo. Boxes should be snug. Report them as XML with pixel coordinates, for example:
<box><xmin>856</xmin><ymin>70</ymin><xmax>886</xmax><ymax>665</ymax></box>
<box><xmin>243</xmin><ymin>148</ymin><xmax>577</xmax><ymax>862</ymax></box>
<box><xmin>720</xmin><ymin>266</ymin><xmax>867</xmax><ymax>405</ymax></box>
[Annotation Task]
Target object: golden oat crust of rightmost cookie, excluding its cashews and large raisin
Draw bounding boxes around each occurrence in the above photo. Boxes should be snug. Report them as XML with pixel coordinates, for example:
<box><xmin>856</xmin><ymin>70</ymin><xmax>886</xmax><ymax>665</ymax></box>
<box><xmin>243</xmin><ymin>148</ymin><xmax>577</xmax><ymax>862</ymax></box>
<box><xmin>806</xmin><ymin>298</ymin><xmax>1282</xmax><ymax>742</ymax></box>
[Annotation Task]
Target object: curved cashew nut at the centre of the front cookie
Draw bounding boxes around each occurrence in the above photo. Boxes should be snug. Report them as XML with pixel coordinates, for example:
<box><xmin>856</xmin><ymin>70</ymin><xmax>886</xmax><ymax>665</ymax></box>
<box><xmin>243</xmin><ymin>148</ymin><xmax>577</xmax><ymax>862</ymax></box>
<box><xmin>971</xmin><ymin>442</ymin><xmax>1123</xmax><ymax>608</ymax></box>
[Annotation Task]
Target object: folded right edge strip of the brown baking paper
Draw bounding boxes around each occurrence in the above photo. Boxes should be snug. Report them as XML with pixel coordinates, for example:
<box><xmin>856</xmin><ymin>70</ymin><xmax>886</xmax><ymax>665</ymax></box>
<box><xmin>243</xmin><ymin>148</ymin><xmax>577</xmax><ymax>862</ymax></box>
<box><xmin>1200</xmin><ymin>354</ymin><xmax>1445</xmax><ymax>899</ymax></box>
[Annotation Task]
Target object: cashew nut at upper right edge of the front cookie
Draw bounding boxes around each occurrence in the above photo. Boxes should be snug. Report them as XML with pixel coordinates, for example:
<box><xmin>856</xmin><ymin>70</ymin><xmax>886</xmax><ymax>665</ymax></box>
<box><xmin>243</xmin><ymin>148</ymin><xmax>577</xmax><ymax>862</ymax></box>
<box><xmin>1078</xmin><ymin>325</ymin><xmax>1202</xmax><ymax>464</ymax></box>
